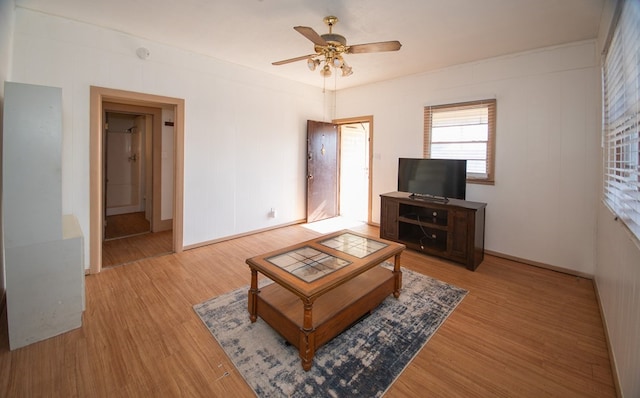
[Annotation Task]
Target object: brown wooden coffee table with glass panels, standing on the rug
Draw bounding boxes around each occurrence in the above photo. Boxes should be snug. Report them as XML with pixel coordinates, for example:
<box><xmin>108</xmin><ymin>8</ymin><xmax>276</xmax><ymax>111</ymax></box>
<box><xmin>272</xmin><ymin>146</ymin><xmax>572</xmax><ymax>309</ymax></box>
<box><xmin>246</xmin><ymin>230</ymin><xmax>405</xmax><ymax>370</ymax></box>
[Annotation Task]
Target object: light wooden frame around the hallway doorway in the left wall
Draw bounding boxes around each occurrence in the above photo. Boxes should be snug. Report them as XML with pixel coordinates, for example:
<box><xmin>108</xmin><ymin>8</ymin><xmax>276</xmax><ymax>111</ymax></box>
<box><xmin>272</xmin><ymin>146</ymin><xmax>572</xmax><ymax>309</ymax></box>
<box><xmin>89</xmin><ymin>86</ymin><xmax>184</xmax><ymax>274</ymax></box>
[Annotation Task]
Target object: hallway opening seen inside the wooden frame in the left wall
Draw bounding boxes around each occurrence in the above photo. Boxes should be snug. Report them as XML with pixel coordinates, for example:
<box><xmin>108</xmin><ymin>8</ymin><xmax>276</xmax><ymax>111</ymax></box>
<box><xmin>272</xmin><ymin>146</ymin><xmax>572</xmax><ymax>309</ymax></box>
<box><xmin>102</xmin><ymin>102</ymin><xmax>174</xmax><ymax>267</ymax></box>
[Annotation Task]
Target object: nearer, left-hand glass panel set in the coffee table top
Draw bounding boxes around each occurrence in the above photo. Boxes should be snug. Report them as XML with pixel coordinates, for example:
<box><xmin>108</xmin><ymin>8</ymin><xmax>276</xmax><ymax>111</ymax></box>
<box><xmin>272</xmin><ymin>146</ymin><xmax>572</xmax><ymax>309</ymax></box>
<box><xmin>266</xmin><ymin>246</ymin><xmax>351</xmax><ymax>282</ymax></box>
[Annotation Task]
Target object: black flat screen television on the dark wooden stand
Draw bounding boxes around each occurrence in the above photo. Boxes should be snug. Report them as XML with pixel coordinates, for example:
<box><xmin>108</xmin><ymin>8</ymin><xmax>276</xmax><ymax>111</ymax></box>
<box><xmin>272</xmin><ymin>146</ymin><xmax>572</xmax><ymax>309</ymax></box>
<box><xmin>398</xmin><ymin>158</ymin><xmax>467</xmax><ymax>200</ymax></box>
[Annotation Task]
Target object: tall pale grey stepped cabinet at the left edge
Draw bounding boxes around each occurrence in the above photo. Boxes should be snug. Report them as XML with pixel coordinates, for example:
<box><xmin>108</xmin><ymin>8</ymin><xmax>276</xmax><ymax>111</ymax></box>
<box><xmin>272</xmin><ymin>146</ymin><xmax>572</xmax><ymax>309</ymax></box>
<box><xmin>2</xmin><ymin>82</ymin><xmax>85</xmax><ymax>350</ymax></box>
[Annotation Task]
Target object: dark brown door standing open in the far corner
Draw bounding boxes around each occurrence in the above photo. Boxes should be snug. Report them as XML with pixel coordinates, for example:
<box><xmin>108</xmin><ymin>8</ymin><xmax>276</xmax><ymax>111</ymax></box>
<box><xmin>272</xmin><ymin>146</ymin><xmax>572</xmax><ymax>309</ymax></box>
<box><xmin>307</xmin><ymin>120</ymin><xmax>339</xmax><ymax>222</ymax></box>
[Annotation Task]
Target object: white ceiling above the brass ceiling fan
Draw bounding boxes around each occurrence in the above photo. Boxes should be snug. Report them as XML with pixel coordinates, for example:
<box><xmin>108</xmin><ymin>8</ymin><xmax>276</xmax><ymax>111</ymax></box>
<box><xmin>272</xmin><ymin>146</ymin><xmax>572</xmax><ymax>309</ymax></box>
<box><xmin>15</xmin><ymin>0</ymin><xmax>605</xmax><ymax>89</ymax></box>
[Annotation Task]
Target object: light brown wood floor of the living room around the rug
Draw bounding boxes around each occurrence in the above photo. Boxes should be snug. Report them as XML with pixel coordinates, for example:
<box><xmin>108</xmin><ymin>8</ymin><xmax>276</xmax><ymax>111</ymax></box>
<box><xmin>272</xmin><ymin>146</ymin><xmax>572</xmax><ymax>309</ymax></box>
<box><xmin>0</xmin><ymin>225</ymin><xmax>616</xmax><ymax>397</ymax></box>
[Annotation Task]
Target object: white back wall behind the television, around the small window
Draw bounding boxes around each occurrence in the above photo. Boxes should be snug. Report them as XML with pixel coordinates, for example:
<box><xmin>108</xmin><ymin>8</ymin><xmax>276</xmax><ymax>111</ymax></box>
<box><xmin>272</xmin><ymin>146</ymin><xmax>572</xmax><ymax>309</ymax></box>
<box><xmin>337</xmin><ymin>41</ymin><xmax>600</xmax><ymax>275</ymax></box>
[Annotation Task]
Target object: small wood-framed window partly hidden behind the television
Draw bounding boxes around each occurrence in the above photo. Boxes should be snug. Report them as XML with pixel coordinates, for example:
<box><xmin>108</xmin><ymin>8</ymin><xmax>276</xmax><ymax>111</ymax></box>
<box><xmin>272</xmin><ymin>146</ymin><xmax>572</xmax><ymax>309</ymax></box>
<box><xmin>424</xmin><ymin>99</ymin><xmax>496</xmax><ymax>184</ymax></box>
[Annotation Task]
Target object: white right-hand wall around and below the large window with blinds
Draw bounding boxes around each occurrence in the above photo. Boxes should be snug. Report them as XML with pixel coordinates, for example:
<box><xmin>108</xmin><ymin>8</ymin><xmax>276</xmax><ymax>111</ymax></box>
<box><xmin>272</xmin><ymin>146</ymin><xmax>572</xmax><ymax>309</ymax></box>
<box><xmin>595</xmin><ymin>0</ymin><xmax>640</xmax><ymax>397</ymax></box>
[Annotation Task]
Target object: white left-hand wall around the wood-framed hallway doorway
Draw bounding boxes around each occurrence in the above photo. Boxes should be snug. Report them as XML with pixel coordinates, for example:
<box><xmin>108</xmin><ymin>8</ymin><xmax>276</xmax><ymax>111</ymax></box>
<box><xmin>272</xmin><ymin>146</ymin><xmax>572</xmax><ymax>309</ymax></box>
<box><xmin>11</xmin><ymin>8</ymin><xmax>324</xmax><ymax>267</ymax></box>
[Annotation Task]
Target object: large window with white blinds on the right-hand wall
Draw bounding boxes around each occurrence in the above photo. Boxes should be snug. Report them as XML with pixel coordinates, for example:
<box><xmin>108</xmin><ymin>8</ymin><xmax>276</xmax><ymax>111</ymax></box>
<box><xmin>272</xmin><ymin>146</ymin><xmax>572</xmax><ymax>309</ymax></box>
<box><xmin>602</xmin><ymin>1</ymin><xmax>640</xmax><ymax>238</ymax></box>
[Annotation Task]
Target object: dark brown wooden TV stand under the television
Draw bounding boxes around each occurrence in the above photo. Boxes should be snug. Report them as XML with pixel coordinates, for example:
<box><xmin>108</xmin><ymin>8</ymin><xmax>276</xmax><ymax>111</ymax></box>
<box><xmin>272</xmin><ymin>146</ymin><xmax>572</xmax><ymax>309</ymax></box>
<box><xmin>380</xmin><ymin>192</ymin><xmax>487</xmax><ymax>271</ymax></box>
